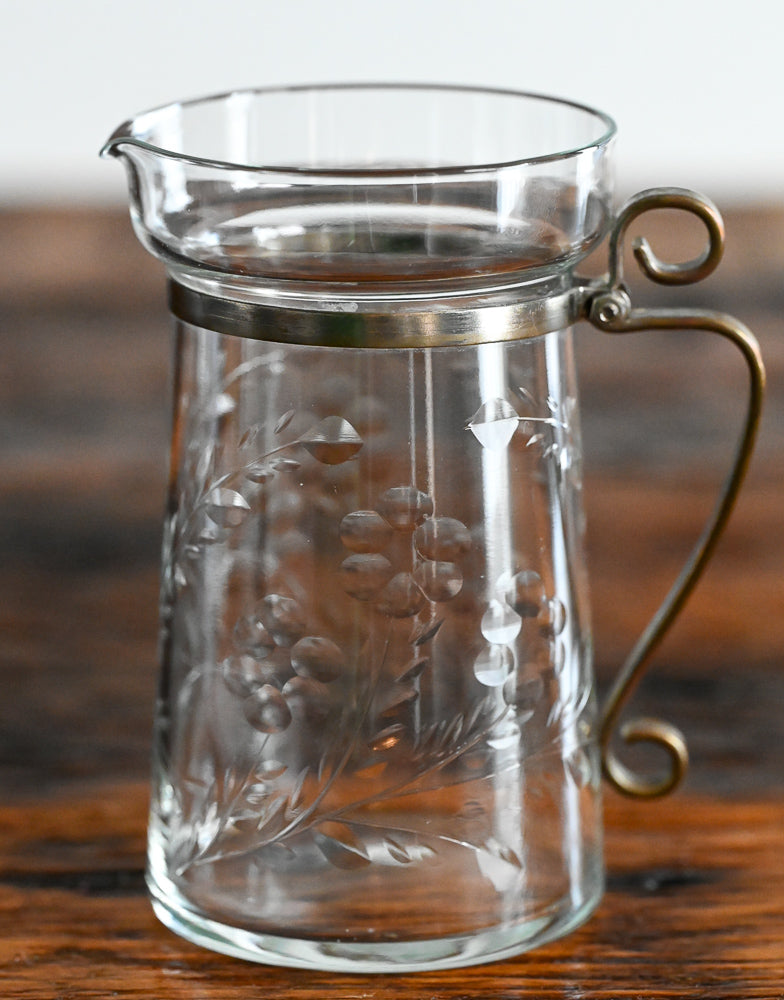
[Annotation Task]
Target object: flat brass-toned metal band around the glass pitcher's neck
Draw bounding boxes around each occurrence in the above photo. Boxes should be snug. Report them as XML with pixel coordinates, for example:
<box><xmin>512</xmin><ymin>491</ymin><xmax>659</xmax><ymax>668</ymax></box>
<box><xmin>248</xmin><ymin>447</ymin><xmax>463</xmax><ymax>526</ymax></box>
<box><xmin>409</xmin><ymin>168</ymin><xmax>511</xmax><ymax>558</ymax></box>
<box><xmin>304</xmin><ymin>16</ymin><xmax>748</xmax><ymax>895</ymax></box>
<box><xmin>169</xmin><ymin>279</ymin><xmax>586</xmax><ymax>348</ymax></box>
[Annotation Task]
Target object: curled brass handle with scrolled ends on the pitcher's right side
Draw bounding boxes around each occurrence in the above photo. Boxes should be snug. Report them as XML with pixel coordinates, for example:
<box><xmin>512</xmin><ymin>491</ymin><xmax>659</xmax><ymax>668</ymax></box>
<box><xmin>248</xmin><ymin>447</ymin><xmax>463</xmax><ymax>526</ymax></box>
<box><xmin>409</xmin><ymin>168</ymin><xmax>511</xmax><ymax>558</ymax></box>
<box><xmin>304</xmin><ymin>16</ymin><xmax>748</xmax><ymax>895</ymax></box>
<box><xmin>585</xmin><ymin>188</ymin><xmax>765</xmax><ymax>798</ymax></box>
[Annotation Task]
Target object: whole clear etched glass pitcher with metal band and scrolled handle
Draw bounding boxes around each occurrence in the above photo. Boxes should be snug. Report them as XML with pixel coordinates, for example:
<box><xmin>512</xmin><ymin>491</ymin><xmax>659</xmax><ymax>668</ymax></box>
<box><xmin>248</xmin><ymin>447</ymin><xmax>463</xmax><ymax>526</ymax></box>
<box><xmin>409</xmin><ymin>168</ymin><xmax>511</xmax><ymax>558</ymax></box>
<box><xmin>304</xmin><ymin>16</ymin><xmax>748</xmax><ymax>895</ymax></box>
<box><xmin>104</xmin><ymin>86</ymin><xmax>762</xmax><ymax>971</ymax></box>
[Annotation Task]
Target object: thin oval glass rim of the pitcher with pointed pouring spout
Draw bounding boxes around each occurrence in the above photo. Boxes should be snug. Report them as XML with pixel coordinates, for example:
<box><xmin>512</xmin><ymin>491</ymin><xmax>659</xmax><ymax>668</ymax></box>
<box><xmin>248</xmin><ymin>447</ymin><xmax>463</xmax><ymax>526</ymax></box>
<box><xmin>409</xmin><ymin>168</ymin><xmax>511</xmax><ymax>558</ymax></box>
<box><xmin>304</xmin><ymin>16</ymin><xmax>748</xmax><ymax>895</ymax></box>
<box><xmin>99</xmin><ymin>82</ymin><xmax>617</xmax><ymax>181</ymax></box>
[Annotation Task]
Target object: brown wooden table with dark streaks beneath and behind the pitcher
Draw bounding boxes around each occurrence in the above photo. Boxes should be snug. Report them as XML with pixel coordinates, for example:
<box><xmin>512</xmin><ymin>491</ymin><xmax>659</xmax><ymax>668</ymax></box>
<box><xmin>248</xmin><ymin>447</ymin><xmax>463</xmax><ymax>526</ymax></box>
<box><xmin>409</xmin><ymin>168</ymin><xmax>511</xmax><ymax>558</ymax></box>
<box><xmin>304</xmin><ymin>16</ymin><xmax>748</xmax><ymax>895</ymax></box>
<box><xmin>0</xmin><ymin>208</ymin><xmax>784</xmax><ymax>1000</ymax></box>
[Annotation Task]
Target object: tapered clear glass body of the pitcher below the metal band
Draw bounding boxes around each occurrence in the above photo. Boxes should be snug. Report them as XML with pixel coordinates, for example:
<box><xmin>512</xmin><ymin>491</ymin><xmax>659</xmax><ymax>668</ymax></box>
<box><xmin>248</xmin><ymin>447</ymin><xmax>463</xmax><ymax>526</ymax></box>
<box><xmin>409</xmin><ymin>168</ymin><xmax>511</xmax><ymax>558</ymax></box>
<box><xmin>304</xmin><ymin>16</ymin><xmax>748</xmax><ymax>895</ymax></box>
<box><xmin>150</xmin><ymin>325</ymin><xmax>602</xmax><ymax>968</ymax></box>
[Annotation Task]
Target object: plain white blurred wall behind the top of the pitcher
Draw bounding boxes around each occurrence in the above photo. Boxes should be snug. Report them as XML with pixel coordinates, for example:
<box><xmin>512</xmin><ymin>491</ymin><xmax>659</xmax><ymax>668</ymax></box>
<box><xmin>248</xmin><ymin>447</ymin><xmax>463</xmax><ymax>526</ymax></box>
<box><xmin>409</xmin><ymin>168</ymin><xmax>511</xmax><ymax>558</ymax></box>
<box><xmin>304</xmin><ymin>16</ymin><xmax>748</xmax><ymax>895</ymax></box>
<box><xmin>0</xmin><ymin>0</ymin><xmax>784</xmax><ymax>203</ymax></box>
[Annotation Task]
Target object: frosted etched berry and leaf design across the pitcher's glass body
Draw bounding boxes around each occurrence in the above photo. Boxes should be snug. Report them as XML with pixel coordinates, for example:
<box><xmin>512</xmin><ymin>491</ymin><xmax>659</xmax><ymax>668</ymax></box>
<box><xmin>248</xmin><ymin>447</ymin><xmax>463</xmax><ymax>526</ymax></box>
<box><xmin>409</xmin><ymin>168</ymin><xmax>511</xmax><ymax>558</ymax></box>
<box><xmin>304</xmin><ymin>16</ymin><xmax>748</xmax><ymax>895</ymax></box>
<box><xmin>161</xmin><ymin>376</ymin><xmax>588</xmax><ymax>874</ymax></box>
